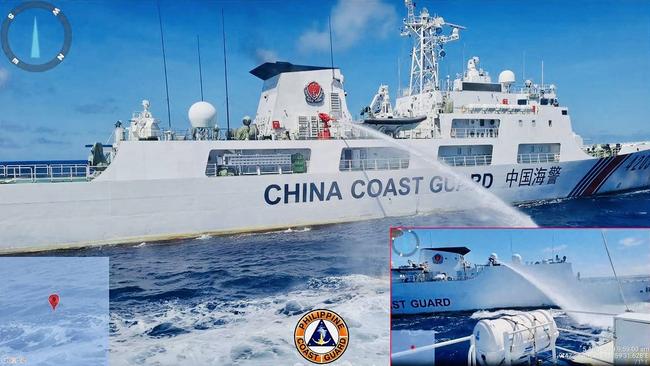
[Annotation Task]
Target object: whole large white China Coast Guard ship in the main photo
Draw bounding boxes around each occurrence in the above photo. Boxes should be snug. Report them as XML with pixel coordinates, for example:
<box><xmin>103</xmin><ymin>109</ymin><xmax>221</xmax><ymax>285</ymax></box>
<box><xmin>0</xmin><ymin>0</ymin><xmax>650</xmax><ymax>252</ymax></box>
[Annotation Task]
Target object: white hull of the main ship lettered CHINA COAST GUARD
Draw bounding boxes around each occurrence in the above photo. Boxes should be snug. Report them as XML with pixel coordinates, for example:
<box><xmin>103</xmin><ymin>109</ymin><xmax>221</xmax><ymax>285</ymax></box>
<box><xmin>0</xmin><ymin>151</ymin><xmax>650</xmax><ymax>253</ymax></box>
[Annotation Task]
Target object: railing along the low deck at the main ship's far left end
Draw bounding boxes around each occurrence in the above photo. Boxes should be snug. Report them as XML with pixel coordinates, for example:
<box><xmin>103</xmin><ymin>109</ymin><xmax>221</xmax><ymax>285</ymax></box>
<box><xmin>0</xmin><ymin>164</ymin><xmax>101</xmax><ymax>183</ymax></box>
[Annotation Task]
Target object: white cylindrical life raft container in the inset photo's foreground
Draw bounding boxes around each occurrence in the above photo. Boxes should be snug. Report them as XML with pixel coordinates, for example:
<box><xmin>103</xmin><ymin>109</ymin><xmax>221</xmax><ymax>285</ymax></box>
<box><xmin>474</xmin><ymin>310</ymin><xmax>558</xmax><ymax>365</ymax></box>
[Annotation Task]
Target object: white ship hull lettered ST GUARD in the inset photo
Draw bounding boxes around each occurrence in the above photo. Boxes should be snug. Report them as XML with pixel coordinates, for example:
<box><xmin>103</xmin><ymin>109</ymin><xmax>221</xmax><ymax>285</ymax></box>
<box><xmin>391</xmin><ymin>263</ymin><xmax>650</xmax><ymax>315</ymax></box>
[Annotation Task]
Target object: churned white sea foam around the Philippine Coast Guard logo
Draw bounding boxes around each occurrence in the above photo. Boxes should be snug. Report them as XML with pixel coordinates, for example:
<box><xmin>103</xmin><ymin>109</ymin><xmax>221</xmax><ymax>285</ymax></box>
<box><xmin>111</xmin><ymin>275</ymin><xmax>389</xmax><ymax>366</ymax></box>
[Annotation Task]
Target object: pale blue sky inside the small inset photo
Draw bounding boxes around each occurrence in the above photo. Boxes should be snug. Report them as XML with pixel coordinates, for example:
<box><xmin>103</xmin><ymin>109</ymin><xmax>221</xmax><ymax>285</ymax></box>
<box><xmin>392</xmin><ymin>228</ymin><xmax>650</xmax><ymax>277</ymax></box>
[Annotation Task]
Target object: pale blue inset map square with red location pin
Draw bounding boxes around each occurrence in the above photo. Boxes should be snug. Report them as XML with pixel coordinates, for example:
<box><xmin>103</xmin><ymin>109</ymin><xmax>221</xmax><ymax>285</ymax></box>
<box><xmin>0</xmin><ymin>257</ymin><xmax>109</xmax><ymax>366</ymax></box>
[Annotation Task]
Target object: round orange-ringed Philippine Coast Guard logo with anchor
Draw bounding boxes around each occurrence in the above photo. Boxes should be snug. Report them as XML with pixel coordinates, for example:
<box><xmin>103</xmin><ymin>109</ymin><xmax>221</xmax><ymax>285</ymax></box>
<box><xmin>294</xmin><ymin>309</ymin><xmax>349</xmax><ymax>364</ymax></box>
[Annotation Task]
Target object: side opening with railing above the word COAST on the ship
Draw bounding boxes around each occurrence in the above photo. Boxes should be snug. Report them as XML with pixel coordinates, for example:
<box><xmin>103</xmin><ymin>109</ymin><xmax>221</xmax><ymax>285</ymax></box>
<box><xmin>339</xmin><ymin>147</ymin><xmax>409</xmax><ymax>171</ymax></box>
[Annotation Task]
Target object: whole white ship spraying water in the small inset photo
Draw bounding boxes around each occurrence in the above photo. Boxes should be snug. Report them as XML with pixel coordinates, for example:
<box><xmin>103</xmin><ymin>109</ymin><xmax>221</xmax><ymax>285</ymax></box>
<box><xmin>391</xmin><ymin>242</ymin><xmax>650</xmax><ymax>315</ymax></box>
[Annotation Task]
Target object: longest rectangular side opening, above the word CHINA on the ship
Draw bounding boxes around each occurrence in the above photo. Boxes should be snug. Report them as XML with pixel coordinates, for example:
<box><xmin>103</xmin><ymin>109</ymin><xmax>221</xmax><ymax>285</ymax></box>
<box><xmin>205</xmin><ymin>149</ymin><xmax>311</xmax><ymax>177</ymax></box>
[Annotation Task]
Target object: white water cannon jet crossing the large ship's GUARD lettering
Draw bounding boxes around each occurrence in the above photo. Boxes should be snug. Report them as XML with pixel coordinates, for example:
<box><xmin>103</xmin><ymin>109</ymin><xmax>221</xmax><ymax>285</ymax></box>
<box><xmin>338</xmin><ymin>120</ymin><xmax>537</xmax><ymax>227</ymax></box>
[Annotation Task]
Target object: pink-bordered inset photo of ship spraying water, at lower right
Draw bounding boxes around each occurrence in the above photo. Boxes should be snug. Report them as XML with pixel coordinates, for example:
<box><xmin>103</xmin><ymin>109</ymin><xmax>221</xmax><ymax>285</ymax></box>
<box><xmin>390</xmin><ymin>227</ymin><xmax>650</xmax><ymax>365</ymax></box>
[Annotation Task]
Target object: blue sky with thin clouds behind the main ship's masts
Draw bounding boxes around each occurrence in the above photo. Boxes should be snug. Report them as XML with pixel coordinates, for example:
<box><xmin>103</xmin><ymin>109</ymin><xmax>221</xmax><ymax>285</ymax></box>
<box><xmin>0</xmin><ymin>0</ymin><xmax>650</xmax><ymax>161</ymax></box>
